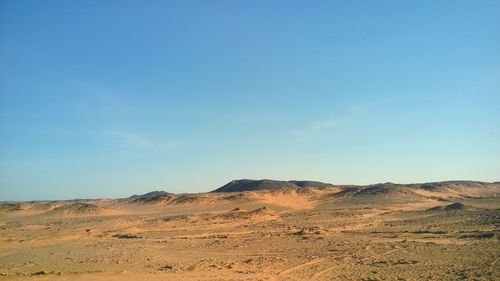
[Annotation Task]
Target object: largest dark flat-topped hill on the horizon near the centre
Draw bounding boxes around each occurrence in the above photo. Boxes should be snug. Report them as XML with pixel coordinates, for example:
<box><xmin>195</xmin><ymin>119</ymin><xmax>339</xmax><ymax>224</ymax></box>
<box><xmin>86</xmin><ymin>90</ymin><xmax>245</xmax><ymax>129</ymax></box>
<box><xmin>212</xmin><ymin>179</ymin><xmax>333</xmax><ymax>192</ymax></box>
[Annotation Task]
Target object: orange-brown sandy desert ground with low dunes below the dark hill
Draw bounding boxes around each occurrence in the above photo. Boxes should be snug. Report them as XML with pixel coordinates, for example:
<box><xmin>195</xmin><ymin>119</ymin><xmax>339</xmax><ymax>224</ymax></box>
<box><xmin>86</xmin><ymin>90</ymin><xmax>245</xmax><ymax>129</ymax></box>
<box><xmin>0</xmin><ymin>182</ymin><xmax>500</xmax><ymax>281</ymax></box>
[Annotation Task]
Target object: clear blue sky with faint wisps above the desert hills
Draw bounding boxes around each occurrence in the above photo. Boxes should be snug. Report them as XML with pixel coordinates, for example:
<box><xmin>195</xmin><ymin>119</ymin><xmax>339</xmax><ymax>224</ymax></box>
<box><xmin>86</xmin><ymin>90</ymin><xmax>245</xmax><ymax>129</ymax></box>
<box><xmin>0</xmin><ymin>0</ymin><xmax>500</xmax><ymax>201</ymax></box>
